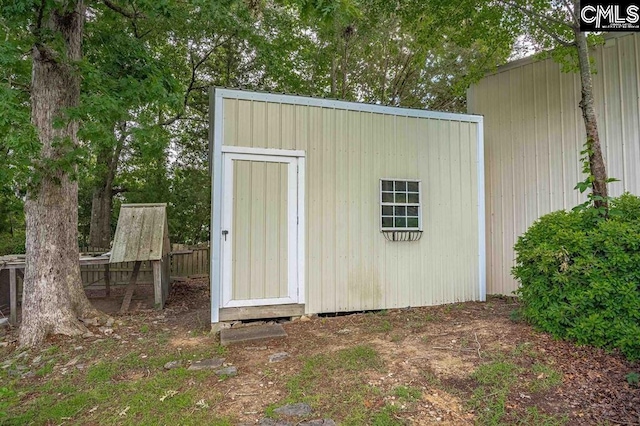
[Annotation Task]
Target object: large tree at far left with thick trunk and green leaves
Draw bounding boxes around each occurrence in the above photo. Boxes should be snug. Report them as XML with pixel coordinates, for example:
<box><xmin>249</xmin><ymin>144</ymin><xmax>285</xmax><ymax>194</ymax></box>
<box><xmin>0</xmin><ymin>0</ymin><xmax>251</xmax><ymax>346</ymax></box>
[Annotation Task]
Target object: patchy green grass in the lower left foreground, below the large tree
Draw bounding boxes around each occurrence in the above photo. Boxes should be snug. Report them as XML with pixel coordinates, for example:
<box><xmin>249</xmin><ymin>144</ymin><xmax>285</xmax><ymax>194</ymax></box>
<box><xmin>0</xmin><ymin>334</ymin><xmax>234</xmax><ymax>425</ymax></box>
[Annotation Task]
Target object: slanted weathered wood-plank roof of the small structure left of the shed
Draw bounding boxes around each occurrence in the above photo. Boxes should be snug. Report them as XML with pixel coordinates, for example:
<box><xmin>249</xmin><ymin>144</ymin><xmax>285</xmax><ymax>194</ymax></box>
<box><xmin>109</xmin><ymin>203</ymin><xmax>169</xmax><ymax>263</ymax></box>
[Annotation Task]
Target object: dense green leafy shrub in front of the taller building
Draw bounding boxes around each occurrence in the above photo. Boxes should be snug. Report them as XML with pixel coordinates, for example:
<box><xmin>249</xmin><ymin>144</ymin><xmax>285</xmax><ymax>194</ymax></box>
<box><xmin>512</xmin><ymin>194</ymin><xmax>640</xmax><ymax>359</ymax></box>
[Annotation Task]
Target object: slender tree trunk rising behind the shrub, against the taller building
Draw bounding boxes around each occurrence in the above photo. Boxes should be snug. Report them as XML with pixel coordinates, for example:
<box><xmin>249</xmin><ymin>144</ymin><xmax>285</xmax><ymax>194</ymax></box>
<box><xmin>573</xmin><ymin>20</ymin><xmax>609</xmax><ymax>209</ymax></box>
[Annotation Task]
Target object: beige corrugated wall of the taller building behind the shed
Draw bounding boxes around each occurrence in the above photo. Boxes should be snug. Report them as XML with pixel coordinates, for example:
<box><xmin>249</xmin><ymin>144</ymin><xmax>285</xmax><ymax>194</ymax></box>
<box><xmin>468</xmin><ymin>33</ymin><xmax>640</xmax><ymax>294</ymax></box>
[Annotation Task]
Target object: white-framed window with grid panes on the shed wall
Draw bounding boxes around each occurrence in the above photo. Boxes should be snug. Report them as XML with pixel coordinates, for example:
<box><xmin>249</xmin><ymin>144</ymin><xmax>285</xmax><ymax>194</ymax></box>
<box><xmin>380</xmin><ymin>179</ymin><xmax>422</xmax><ymax>231</ymax></box>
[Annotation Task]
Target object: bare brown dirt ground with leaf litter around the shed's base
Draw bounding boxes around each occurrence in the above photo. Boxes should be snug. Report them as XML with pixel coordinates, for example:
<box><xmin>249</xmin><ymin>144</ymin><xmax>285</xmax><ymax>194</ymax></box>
<box><xmin>4</xmin><ymin>280</ymin><xmax>640</xmax><ymax>425</ymax></box>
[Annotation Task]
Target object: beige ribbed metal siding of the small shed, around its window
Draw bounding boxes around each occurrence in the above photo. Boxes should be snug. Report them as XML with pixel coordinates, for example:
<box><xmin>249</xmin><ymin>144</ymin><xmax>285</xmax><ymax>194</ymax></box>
<box><xmin>223</xmin><ymin>99</ymin><xmax>480</xmax><ymax>313</ymax></box>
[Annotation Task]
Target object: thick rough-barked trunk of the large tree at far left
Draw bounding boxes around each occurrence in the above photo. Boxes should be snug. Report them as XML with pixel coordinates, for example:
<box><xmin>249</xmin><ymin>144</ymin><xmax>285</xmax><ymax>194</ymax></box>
<box><xmin>20</xmin><ymin>0</ymin><xmax>100</xmax><ymax>346</ymax></box>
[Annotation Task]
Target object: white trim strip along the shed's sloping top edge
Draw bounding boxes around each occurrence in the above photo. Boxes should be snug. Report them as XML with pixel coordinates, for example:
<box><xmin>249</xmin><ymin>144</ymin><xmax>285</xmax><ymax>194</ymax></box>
<box><xmin>214</xmin><ymin>87</ymin><xmax>482</xmax><ymax>123</ymax></box>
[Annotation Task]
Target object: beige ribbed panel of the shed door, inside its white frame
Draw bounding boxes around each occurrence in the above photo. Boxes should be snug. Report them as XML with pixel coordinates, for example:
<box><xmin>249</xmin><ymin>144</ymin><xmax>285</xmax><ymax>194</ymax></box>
<box><xmin>231</xmin><ymin>161</ymin><xmax>288</xmax><ymax>300</ymax></box>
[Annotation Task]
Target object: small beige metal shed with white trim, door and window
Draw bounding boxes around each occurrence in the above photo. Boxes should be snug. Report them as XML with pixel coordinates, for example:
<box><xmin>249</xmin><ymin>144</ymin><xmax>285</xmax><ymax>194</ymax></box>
<box><xmin>210</xmin><ymin>89</ymin><xmax>485</xmax><ymax>323</ymax></box>
